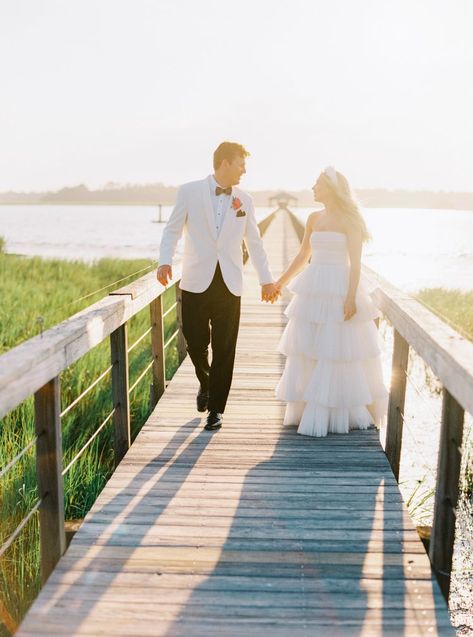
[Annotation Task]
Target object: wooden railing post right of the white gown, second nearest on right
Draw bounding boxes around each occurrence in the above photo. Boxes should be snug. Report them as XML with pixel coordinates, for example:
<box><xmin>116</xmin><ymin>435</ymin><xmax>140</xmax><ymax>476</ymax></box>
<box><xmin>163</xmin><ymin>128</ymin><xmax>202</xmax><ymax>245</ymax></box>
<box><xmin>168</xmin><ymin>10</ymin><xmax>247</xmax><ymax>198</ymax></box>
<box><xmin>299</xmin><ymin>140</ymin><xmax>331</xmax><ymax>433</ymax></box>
<box><xmin>386</xmin><ymin>329</ymin><xmax>409</xmax><ymax>481</ymax></box>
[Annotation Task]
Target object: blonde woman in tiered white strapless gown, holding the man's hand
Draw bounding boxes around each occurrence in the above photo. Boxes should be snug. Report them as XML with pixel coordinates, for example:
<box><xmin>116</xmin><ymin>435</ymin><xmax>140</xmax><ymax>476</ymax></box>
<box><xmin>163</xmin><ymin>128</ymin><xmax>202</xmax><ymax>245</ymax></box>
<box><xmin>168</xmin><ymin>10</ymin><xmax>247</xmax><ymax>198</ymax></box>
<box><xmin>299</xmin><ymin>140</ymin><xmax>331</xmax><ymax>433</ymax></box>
<box><xmin>276</xmin><ymin>166</ymin><xmax>387</xmax><ymax>436</ymax></box>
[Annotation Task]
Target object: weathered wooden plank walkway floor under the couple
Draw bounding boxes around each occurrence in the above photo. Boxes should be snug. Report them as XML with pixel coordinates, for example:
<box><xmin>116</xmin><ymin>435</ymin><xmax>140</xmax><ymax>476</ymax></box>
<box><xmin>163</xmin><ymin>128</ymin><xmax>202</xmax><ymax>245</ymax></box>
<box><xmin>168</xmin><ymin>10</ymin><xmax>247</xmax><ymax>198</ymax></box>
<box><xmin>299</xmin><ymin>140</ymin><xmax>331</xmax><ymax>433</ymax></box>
<box><xmin>17</xmin><ymin>211</ymin><xmax>455</xmax><ymax>637</ymax></box>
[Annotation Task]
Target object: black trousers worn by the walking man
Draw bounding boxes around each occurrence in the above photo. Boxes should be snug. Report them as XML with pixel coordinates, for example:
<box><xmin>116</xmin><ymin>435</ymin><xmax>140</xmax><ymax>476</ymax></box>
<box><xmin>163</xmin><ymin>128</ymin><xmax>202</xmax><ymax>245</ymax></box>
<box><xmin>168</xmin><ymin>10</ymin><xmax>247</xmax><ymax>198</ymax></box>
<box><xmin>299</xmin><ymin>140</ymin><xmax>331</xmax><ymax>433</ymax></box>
<box><xmin>182</xmin><ymin>264</ymin><xmax>241</xmax><ymax>413</ymax></box>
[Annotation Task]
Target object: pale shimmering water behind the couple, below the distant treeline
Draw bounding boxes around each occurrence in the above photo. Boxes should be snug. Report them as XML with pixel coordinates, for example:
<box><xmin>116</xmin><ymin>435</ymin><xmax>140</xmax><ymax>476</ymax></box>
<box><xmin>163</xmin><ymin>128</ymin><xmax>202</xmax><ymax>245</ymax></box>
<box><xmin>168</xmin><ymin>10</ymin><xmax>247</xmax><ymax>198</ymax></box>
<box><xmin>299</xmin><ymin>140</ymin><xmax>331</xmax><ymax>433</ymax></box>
<box><xmin>0</xmin><ymin>205</ymin><xmax>473</xmax><ymax>292</ymax></box>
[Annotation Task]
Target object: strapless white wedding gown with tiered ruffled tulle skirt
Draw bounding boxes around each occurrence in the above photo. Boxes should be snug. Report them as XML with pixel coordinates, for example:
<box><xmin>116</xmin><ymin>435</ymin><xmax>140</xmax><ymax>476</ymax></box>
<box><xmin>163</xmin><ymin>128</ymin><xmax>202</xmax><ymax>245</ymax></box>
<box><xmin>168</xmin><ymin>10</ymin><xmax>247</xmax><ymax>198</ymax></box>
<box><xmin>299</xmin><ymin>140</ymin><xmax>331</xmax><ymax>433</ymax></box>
<box><xmin>276</xmin><ymin>231</ymin><xmax>387</xmax><ymax>436</ymax></box>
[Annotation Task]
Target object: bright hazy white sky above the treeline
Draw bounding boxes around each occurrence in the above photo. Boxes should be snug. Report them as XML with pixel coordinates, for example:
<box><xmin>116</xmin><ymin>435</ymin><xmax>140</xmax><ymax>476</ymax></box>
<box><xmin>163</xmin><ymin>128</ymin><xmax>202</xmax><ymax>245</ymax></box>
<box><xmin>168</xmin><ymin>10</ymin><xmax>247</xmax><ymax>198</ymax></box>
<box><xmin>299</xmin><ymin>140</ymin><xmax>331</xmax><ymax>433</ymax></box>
<box><xmin>0</xmin><ymin>0</ymin><xmax>473</xmax><ymax>192</ymax></box>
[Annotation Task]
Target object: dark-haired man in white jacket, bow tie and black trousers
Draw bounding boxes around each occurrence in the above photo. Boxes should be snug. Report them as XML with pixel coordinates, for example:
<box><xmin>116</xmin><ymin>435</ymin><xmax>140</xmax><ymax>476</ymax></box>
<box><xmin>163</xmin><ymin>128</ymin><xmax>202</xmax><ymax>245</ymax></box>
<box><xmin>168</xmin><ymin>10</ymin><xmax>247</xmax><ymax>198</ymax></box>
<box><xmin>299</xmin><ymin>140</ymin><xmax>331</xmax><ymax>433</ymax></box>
<box><xmin>157</xmin><ymin>142</ymin><xmax>279</xmax><ymax>430</ymax></box>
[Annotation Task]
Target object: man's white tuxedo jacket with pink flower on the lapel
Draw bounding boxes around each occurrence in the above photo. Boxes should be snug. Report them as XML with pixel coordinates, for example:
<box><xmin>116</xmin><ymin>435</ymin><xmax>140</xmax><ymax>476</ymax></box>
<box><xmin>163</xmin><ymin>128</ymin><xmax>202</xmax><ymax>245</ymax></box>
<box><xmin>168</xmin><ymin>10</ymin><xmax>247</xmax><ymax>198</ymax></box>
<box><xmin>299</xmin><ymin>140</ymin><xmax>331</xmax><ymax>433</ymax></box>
<box><xmin>159</xmin><ymin>177</ymin><xmax>273</xmax><ymax>296</ymax></box>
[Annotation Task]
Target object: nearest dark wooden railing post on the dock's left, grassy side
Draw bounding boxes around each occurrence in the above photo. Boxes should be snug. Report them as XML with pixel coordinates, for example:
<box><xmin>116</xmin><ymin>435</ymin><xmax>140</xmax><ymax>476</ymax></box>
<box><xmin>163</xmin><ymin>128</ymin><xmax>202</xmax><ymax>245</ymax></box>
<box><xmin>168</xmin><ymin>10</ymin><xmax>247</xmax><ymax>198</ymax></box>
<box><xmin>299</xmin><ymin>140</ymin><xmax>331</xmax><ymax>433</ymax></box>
<box><xmin>34</xmin><ymin>376</ymin><xmax>66</xmax><ymax>584</ymax></box>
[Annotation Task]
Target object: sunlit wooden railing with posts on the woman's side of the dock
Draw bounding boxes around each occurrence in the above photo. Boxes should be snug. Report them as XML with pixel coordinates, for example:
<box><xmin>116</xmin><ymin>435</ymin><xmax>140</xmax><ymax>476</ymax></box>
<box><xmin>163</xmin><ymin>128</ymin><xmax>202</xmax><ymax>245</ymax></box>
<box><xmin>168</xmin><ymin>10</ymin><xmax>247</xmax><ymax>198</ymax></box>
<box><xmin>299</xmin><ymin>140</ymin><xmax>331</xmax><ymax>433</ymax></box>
<box><xmin>290</xmin><ymin>213</ymin><xmax>473</xmax><ymax>599</ymax></box>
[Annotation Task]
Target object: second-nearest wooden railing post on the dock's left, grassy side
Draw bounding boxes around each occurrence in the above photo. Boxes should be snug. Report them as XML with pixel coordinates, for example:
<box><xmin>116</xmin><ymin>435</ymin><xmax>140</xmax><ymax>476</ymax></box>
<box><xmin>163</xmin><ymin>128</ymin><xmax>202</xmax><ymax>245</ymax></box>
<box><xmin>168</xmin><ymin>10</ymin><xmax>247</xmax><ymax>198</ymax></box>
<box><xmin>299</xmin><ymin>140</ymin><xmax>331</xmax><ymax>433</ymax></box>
<box><xmin>110</xmin><ymin>323</ymin><xmax>131</xmax><ymax>466</ymax></box>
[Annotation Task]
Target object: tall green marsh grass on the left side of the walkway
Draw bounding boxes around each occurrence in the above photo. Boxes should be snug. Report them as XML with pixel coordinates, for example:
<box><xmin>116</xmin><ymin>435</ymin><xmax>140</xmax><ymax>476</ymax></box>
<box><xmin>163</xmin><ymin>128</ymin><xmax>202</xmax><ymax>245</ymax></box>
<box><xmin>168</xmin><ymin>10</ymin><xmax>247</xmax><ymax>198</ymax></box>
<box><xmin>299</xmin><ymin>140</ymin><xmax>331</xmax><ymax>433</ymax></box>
<box><xmin>0</xmin><ymin>251</ymin><xmax>177</xmax><ymax>637</ymax></box>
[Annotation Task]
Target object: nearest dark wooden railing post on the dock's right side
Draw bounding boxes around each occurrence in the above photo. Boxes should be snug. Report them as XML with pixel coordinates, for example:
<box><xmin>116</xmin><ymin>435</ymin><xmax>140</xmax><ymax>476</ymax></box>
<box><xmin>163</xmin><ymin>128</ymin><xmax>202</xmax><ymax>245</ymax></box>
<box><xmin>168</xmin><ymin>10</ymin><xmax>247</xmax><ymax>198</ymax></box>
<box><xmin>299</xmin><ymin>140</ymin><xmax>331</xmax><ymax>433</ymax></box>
<box><xmin>429</xmin><ymin>388</ymin><xmax>465</xmax><ymax>599</ymax></box>
